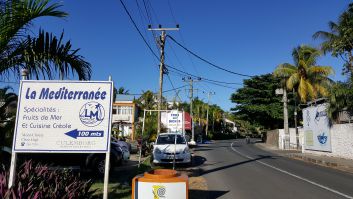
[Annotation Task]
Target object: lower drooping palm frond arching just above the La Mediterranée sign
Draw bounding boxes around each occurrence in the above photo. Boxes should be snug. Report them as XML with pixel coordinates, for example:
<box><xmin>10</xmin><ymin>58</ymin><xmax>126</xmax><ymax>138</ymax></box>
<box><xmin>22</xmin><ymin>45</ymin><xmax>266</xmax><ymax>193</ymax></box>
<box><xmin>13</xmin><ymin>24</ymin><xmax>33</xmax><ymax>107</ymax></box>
<box><xmin>0</xmin><ymin>30</ymin><xmax>92</xmax><ymax>80</ymax></box>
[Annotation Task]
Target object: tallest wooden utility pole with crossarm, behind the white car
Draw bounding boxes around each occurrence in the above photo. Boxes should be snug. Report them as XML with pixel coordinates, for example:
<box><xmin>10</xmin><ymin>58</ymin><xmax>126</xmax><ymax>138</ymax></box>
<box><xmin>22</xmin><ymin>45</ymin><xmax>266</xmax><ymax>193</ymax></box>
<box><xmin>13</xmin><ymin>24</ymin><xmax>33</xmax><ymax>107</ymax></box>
<box><xmin>148</xmin><ymin>25</ymin><xmax>179</xmax><ymax>135</ymax></box>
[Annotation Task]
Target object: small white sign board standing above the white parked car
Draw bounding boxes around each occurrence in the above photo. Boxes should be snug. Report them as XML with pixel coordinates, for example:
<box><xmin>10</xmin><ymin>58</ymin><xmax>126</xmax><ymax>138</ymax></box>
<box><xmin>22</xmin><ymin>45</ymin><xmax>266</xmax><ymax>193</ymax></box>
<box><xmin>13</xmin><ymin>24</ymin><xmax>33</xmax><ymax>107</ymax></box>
<box><xmin>161</xmin><ymin>110</ymin><xmax>184</xmax><ymax>132</ymax></box>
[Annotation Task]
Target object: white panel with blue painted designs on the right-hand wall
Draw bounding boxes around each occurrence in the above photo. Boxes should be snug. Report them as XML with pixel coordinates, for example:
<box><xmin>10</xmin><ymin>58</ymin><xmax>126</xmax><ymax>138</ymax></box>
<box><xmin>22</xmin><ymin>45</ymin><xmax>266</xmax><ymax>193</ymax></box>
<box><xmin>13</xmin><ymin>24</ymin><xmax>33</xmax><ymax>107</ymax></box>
<box><xmin>303</xmin><ymin>104</ymin><xmax>332</xmax><ymax>152</ymax></box>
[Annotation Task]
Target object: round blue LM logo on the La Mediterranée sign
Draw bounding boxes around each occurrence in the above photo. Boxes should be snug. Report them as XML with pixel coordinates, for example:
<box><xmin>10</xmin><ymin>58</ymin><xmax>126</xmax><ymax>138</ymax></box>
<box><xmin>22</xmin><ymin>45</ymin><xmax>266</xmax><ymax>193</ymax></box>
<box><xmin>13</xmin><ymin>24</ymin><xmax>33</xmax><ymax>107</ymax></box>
<box><xmin>79</xmin><ymin>102</ymin><xmax>104</xmax><ymax>127</ymax></box>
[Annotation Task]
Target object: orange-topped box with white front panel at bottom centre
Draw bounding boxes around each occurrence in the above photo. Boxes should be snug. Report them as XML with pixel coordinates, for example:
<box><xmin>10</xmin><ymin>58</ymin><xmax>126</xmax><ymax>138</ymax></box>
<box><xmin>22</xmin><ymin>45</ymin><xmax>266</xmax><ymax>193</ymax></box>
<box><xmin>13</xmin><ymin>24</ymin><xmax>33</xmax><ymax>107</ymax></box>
<box><xmin>132</xmin><ymin>169</ymin><xmax>189</xmax><ymax>199</ymax></box>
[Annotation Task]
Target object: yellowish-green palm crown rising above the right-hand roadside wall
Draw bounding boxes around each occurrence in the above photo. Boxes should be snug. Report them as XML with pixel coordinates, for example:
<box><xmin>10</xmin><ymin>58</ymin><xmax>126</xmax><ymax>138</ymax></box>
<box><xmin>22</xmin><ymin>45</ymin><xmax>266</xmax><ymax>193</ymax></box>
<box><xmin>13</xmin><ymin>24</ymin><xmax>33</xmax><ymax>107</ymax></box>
<box><xmin>274</xmin><ymin>45</ymin><xmax>334</xmax><ymax>102</ymax></box>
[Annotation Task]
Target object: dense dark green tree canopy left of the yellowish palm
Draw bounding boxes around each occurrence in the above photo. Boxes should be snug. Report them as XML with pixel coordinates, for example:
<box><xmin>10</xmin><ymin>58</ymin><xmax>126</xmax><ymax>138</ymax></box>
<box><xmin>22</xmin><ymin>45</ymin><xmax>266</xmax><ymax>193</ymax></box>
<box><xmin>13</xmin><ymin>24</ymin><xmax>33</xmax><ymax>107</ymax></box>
<box><xmin>230</xmin><ymin>74</ymin><xmax>290</xmax><ymax>131</ymax></box>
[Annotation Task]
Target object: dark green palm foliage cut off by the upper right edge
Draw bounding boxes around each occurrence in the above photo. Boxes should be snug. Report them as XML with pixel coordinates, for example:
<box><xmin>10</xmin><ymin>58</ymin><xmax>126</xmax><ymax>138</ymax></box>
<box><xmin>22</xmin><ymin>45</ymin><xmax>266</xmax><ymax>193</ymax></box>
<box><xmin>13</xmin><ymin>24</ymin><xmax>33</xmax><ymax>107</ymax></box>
<box><xmin>313</xmin><ymin>3</ymin><xmax>353</xmax><ymax>77</ymax></box>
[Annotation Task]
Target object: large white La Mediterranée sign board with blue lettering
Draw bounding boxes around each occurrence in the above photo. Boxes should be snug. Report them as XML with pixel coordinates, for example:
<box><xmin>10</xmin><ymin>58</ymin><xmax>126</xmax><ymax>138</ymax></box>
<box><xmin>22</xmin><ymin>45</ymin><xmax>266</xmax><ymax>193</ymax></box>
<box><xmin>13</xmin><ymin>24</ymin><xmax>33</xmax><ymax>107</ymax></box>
<box><xmin>13</xmin><ymin>80</ymin><xmax>113</xmax><ymax>153</ymax></box>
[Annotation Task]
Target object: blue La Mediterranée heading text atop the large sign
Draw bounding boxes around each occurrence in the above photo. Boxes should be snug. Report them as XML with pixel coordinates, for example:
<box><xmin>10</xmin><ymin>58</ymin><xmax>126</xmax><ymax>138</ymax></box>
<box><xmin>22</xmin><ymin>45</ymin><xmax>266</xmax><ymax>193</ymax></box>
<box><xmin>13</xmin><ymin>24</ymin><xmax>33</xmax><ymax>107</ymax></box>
<box><xmin>26</xmin><ymin>87</ymin><xmax>107</xmax><ymax>100</ymax></box>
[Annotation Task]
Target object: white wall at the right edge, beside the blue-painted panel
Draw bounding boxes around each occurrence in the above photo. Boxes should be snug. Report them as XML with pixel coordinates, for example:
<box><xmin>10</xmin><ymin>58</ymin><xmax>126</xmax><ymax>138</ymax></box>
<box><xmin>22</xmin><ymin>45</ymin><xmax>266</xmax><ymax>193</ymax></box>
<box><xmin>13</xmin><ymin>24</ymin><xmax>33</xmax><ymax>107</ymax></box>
<box><xmin>304</xmin><ymin>124</ymin><xmax>353</xmax><ymax>159</ymax></box>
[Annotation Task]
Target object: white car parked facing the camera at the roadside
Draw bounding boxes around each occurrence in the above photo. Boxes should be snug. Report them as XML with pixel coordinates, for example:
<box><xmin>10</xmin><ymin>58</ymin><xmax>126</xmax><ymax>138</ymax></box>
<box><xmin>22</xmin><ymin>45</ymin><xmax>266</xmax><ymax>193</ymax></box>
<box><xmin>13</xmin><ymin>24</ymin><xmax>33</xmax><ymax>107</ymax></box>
<box><xmin>153</xmin><ymin>133</ymin><xmax>191</xmax><ymax>164</ymax></box>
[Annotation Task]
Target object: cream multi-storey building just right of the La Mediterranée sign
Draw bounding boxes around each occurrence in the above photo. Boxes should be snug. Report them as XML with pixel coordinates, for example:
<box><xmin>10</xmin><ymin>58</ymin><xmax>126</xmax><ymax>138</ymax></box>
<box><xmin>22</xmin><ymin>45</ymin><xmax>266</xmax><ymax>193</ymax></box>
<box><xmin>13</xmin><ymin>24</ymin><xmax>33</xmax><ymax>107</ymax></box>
<box><xmin>112</xmin><ymin>95</ymin><xmax>138</xmax><ymax>140</ymax></box>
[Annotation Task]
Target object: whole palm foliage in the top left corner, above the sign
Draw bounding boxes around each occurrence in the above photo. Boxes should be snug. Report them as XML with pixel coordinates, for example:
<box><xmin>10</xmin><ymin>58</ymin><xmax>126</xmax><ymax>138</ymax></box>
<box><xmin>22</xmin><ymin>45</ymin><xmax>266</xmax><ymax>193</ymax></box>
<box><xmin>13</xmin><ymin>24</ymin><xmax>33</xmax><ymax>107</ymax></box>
<box><xmin>0</xmin><ymin>0</ymin><xmax>91</xmax><ymax>80</ymax></box>
